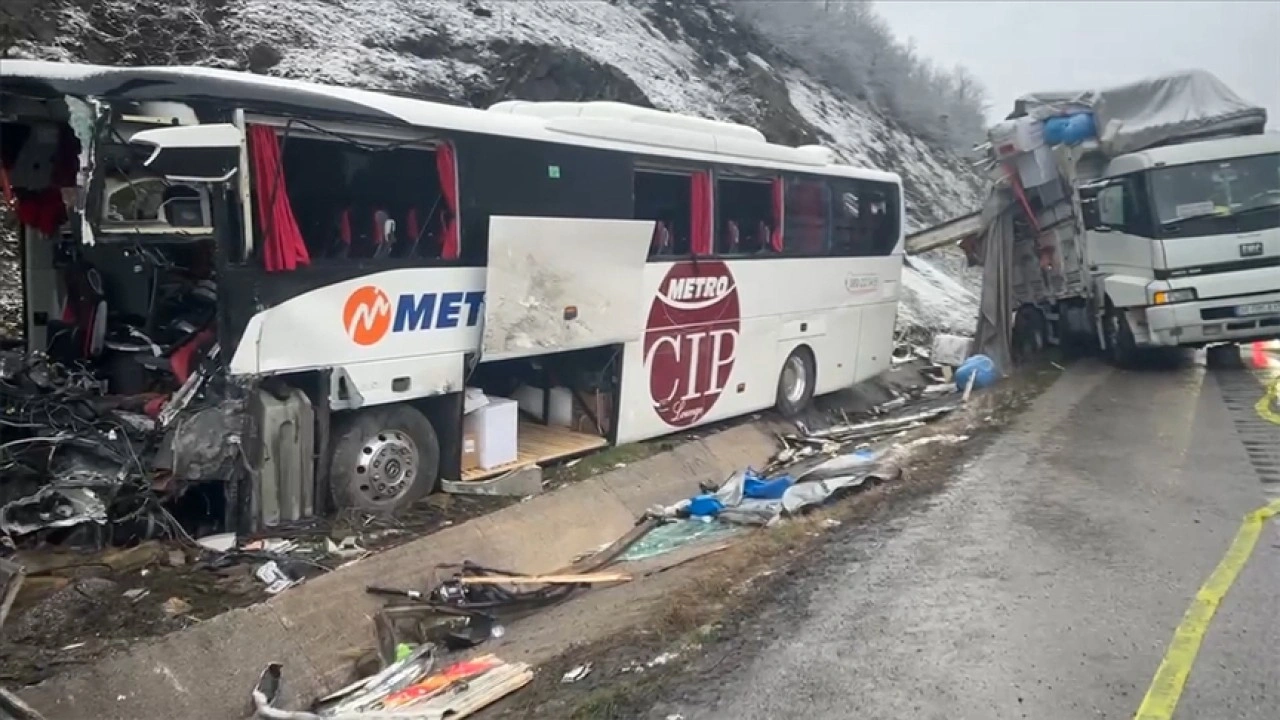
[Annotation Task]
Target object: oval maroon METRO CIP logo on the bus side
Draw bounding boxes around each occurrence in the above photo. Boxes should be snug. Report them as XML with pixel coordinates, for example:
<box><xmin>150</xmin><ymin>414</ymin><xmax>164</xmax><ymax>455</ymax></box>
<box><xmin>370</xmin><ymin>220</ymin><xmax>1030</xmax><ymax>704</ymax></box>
<box><xmin>644</xmin><ymin>260</ymin><xmax>741</xmax><ymax>428</ymax></box>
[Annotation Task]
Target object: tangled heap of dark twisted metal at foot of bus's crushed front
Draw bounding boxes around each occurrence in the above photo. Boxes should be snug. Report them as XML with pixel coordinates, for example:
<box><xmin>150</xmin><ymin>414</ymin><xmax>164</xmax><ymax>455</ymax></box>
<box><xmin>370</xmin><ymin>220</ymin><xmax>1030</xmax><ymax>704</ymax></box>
<box><xmin>0</xmin><ymin>347</ymin><xmax>240</xmax><ymax>544</ymax></box>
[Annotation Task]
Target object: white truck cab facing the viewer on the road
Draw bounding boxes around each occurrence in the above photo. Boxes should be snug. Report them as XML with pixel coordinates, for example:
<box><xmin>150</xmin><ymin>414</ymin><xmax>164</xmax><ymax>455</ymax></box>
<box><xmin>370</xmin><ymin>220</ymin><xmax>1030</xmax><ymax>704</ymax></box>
<box><xmin>1080</xmin><ymin>133</ymin><xmax>1280</xmax><ymax>350</ymax></box>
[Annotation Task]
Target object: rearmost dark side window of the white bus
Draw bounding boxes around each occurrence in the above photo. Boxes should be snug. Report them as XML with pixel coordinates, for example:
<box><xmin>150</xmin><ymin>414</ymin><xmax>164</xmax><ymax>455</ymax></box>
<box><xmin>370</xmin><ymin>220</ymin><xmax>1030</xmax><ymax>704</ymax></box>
<box><xmin>831</xmin><ymin>179</ymin><xmax>899</xmax><ymax>258</ymax></box>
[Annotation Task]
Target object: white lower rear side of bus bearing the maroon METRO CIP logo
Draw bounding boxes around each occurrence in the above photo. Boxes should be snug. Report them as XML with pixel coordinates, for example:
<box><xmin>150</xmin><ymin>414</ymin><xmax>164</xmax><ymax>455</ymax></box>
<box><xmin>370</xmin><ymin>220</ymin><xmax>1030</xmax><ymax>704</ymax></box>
<box><xmin>617</xmin><ymin>256</ymin><xmax>902</xmax><ymax>442</ymax></box>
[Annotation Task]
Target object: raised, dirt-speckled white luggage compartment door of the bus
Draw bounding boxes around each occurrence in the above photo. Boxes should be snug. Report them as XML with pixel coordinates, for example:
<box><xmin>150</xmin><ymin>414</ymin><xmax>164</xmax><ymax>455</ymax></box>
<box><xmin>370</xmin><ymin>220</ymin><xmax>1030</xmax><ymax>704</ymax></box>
<box><xmin>481</xmin><ymin>217</ymin><xmax>654</xmax><ymax>360</ymax></box>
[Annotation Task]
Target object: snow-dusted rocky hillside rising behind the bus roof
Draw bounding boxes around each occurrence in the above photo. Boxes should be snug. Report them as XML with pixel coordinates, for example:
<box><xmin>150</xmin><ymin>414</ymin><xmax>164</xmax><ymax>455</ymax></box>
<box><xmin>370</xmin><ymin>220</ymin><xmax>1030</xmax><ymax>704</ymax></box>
<box><xmin>0</xmin><ymin>0</ymin><xmax>982</xmax><ymax>329</ymax></box>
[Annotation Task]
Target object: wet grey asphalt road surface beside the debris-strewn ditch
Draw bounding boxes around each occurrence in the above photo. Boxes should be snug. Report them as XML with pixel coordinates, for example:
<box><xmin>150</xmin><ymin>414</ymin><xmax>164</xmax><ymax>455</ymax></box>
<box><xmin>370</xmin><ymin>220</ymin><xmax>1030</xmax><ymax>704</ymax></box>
<box><xmin>654</xmin><ymin>363</ymin><xmax>1280</xmax><ymax>720</ymax></box>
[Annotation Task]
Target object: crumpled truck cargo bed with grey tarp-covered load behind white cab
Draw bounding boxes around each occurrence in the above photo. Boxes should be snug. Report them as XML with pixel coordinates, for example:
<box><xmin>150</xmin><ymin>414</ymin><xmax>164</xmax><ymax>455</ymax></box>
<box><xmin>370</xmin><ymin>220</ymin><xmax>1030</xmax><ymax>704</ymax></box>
<box><xmin>961</xmin><ymin>70</ymin><xmax>1280</xmax><ymax>366</ymax></box>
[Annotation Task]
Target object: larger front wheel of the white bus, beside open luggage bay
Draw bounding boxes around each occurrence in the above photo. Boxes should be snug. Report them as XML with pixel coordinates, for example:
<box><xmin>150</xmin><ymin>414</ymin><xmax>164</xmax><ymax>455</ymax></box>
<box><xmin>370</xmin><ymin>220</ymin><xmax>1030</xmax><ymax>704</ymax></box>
<box><xmin>329</xmin><ymin>405</ymin><xmax>440</xmax><ymax>514</ymax></box>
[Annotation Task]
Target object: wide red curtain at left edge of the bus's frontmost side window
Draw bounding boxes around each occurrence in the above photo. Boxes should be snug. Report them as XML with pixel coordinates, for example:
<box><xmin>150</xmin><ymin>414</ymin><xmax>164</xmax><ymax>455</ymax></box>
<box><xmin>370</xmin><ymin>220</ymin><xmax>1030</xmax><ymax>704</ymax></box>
<box><xmin>248</xmin><ymin>126</ymin><xmax>311</xmax><ymax>272</ymax></box>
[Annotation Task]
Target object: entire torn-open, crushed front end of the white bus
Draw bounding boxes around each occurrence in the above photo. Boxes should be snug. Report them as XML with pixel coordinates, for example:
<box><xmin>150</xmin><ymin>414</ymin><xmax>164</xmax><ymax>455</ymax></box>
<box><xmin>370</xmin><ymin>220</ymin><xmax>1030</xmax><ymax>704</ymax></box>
<box><xmin>0</xmin><ymin>61</ymin><xmax>262</xmax><ymax>546</ymax></box>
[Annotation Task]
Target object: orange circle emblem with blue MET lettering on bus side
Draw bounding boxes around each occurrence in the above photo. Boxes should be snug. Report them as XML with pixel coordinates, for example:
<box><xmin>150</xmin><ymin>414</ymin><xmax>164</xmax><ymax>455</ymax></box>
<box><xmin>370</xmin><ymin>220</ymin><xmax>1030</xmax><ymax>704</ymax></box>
<box><xmin>342</xmin><ymin>284</ymin><xmax>484</xmax><ymax>347</ymax></box>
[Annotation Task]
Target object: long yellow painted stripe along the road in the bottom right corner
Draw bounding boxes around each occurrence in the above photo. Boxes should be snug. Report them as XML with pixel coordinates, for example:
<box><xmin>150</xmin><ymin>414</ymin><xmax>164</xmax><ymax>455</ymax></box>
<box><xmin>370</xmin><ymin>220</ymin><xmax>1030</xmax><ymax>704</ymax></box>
<box><xmin>1134</xmin><ymin>499</ymin><xmax>1280</xmax><ymax>720</ymax></box>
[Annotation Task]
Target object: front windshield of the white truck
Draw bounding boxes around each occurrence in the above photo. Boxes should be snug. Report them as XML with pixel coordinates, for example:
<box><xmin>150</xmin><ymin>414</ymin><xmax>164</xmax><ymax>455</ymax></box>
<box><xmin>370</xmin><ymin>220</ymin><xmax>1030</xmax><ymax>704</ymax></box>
<box><xmin>1151</xmin><ymin>154</ymin><xmax>1280</xmax><ymax>237</ymax></box>
